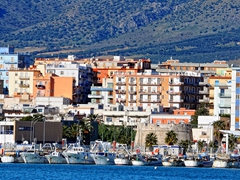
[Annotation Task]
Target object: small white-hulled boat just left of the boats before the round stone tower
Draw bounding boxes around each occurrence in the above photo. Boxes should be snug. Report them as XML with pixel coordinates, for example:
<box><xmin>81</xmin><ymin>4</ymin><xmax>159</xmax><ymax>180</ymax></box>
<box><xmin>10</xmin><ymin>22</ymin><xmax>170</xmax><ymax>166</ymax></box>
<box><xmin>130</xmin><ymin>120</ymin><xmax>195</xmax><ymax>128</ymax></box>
<box><xmin>114</xmin><ymin>144</ymin><xmax>132</xmax><ymax>165</ymax></box>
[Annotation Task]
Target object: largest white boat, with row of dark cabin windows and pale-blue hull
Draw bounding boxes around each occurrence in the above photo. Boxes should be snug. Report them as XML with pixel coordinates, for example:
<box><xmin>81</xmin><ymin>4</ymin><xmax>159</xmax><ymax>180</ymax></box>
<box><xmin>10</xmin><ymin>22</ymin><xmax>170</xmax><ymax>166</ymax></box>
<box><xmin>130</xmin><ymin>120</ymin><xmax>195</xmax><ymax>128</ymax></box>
<box><xmin>62</xmin><ymin>143</ymin><xmax>94</xmax><ymax>164</ymax></box>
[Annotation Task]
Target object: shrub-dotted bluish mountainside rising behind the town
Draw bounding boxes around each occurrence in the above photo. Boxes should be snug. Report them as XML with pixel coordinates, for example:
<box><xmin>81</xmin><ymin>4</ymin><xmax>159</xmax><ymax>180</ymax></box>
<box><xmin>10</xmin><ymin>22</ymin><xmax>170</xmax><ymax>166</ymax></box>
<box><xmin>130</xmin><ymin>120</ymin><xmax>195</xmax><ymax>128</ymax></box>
<box><xmin>0</xmin><ymin>0</ymin><xmax>240</xmax><ymax>63</ymax></box>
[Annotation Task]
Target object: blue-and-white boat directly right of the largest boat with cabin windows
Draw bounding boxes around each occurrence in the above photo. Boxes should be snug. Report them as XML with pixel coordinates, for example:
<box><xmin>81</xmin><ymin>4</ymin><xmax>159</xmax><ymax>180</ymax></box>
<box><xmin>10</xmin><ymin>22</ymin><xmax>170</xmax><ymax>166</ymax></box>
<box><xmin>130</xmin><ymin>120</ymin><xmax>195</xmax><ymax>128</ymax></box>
<box><xmin>91</xmin><ymin>140</ymin><xmax>116</xmax><ymax>165</ymax></box>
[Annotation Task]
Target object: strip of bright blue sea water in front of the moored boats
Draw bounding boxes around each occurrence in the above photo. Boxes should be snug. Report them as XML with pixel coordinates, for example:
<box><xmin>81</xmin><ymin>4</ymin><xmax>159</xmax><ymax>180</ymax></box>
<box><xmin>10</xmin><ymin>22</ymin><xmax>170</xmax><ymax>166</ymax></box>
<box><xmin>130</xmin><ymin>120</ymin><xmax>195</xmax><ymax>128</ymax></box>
<box><xmin>0</xmin><ymin>163</ymin><xmax>240</xmax><ymax>180</ymax></box>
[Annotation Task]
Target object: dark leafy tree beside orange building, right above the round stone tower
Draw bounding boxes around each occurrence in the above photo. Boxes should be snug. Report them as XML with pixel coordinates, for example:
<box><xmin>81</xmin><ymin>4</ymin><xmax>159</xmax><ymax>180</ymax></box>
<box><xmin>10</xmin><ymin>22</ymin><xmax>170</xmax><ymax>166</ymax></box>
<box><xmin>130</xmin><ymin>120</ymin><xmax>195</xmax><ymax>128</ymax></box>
<box><xmin>191</xmin><ymin>103</ymin><xmax>209</xmax><ymax>128</ymax></box>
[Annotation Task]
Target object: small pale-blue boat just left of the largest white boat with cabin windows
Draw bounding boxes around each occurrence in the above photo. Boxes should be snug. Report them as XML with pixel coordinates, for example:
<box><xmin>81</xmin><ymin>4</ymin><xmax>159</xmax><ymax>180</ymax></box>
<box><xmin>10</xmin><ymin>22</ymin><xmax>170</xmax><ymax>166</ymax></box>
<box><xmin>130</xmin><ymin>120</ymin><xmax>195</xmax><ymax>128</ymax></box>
<box><xmin>45</xmin><ymin>143</ymin><xmax>67</xmax><ymax>164</ymax></box>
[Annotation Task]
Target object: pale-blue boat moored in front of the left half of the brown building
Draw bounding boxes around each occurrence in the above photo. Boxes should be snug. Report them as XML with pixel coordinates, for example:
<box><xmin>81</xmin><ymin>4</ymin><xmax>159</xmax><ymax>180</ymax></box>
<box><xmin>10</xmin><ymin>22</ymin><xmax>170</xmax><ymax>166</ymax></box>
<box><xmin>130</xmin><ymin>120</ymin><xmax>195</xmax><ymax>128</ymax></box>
<box><xmin>20</xmin><ymin>143</ymin><xmax>52</xmax><ymax>164</ymax></box>
